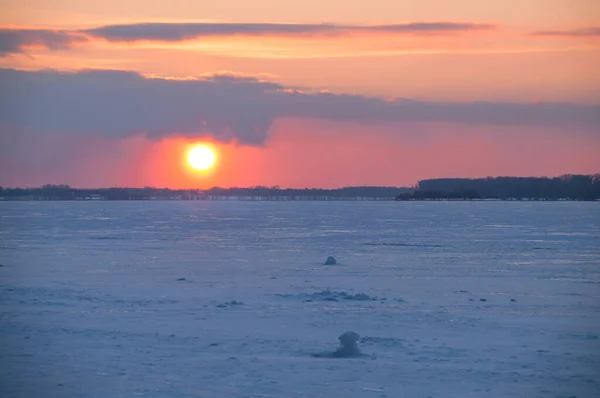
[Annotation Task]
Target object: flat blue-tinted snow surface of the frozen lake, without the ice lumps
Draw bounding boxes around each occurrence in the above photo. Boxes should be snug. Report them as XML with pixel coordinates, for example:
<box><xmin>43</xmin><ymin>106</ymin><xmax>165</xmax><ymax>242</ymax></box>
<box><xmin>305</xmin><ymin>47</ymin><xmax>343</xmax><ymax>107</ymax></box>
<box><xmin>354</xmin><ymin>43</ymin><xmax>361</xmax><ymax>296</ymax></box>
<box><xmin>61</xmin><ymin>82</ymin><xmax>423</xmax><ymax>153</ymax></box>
<box><xmin>0</xmin><ymin>202</ymin><xmax>600</xmax><ymax>398</ymax></box>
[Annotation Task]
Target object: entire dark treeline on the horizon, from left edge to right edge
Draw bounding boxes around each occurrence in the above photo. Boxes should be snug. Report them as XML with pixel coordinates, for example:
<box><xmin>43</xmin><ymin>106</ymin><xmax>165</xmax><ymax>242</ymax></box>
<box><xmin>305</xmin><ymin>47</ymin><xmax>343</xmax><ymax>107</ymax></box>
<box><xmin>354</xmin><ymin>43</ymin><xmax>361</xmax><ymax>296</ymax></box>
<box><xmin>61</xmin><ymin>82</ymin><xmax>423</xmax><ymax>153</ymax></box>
<box><xmin>0</xmin><ymin>174</ymin><xmax>600</xmax><ymax>201</ymax></box>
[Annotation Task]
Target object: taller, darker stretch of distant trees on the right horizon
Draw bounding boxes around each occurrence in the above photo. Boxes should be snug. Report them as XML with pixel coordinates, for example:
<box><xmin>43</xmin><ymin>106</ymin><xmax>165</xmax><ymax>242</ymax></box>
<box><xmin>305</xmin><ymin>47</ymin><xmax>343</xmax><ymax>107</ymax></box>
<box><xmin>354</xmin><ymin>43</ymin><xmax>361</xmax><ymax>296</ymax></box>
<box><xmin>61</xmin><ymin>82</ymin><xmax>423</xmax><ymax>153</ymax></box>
<box><xmin>396</xmin><ymin>174</ymin><xmax>600</xmax><ymax>200</ymax></box>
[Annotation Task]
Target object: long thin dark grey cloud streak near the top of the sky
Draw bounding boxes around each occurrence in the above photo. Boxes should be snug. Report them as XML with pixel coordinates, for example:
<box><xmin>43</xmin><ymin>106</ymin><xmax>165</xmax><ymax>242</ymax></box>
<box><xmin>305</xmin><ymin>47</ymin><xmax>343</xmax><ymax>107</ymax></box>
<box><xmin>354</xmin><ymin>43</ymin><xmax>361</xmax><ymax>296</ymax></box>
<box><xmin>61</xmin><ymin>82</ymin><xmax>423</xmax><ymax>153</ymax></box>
<box><xmin>82</xmin><ymin>22</ymin><xmax>494</xmax><ymax>42</ymax></box>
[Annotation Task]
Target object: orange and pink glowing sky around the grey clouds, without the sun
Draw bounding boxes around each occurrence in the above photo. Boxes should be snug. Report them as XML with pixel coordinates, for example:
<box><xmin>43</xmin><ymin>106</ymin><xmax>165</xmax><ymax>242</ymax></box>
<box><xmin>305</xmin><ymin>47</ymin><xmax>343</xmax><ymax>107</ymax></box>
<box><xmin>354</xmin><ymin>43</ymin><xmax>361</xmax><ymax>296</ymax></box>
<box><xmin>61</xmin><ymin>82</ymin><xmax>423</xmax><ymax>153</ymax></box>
<box><xmin>0</xmin><ymin>0</ymin><xmax>600</xmax><ymax>188</ymax></box>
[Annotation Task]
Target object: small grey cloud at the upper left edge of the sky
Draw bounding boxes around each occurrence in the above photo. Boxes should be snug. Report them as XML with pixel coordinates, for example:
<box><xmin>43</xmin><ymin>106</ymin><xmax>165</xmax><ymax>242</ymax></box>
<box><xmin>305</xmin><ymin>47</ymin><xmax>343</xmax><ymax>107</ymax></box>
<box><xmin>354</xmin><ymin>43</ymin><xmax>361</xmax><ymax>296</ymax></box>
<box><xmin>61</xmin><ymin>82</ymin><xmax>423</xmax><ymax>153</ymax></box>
<box><xmin>0</xmin><ymin>28</ymin><xmax>87</xmax><ymax>56</ymax></box>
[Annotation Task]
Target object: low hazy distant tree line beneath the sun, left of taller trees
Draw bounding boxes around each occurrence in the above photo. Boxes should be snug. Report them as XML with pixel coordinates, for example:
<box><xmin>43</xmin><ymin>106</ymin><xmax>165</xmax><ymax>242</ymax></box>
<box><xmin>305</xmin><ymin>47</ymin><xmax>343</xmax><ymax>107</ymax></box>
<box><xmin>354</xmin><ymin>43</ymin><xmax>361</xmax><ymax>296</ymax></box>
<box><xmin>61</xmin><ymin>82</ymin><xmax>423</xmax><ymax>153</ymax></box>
<box><xmin>0</xmin><ymin>184</ymin><xmax>411</xmax><ymax>200</ymax></box>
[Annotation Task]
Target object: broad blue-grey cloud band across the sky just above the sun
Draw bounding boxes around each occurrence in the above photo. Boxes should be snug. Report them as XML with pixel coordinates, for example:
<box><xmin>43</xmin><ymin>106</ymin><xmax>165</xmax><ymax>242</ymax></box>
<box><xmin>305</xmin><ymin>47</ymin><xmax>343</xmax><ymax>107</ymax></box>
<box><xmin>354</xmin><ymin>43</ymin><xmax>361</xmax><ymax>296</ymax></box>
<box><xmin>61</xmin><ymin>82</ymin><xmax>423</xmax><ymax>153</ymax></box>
<box><xmin>0</xmin><ymin>69</ymin><xmax>600</xmax><ymax>146</ymax></box>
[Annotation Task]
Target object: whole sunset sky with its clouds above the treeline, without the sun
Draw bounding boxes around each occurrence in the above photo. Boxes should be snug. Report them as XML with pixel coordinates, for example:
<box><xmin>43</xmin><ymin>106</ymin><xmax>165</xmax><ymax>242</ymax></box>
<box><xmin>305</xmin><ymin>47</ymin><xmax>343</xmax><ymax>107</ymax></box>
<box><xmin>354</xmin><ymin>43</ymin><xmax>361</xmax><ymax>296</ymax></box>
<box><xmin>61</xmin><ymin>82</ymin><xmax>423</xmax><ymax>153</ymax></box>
<box><xmin>0</xmin><ymin>0</ymin><xmax>600</xmax><ymax>188</ymax></box>
